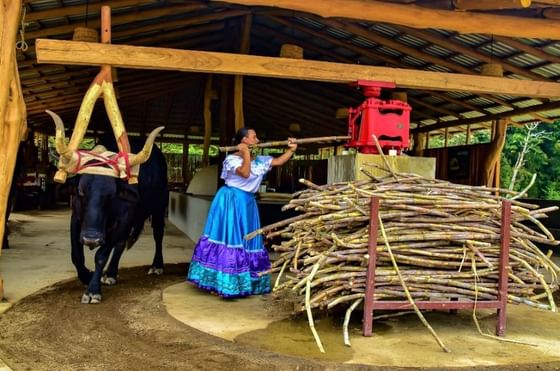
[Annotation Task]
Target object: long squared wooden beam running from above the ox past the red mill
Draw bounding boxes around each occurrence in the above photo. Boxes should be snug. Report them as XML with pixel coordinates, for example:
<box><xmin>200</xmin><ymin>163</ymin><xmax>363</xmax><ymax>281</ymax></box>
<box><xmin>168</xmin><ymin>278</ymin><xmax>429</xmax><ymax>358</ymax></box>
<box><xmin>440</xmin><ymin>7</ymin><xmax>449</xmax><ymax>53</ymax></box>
<box><xmin>36</xmin><ymin>39</ymin><xmax>560</xmax><ymax>98</ymax></box>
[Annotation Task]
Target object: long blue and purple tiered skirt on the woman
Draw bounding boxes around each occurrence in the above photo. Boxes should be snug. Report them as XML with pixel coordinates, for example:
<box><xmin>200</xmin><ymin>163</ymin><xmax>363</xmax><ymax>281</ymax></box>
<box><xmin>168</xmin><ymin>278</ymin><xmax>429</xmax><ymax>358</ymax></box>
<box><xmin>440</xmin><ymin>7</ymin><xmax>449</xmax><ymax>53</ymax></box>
<box><xmin>187</xmin><ymin>185</ymin><xmax>270</xmax><ymax>298</ymax></box>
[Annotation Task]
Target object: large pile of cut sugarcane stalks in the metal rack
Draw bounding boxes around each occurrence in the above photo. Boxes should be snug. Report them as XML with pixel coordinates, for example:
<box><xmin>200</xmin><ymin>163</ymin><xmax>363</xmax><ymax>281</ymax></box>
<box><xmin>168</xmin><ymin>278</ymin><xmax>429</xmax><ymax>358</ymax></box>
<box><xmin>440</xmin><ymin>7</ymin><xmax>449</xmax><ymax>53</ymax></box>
<box><xmin>246</xmin><ymin>165</ymin><xmax>560</xmax><ymax>348</ymax></box>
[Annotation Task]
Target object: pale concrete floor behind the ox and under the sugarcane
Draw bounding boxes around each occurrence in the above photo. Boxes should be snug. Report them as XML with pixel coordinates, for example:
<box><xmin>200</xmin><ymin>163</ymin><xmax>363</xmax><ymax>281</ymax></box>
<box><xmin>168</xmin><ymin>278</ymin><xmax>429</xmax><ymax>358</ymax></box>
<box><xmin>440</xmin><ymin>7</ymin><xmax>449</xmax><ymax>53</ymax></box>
<box><xmin>0</xmin><ymin>210</ymin><xmax>560</xmax><ymax>371</ymax></box>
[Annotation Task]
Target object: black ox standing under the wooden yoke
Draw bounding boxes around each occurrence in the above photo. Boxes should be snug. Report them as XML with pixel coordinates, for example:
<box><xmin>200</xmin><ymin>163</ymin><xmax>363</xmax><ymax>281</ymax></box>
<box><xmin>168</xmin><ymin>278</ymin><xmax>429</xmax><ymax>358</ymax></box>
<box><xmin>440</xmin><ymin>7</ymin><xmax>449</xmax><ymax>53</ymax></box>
<box><xmin>71</xmin><ymin>141</ymin><xmax>169</xmax><ymax>303</ymax></box>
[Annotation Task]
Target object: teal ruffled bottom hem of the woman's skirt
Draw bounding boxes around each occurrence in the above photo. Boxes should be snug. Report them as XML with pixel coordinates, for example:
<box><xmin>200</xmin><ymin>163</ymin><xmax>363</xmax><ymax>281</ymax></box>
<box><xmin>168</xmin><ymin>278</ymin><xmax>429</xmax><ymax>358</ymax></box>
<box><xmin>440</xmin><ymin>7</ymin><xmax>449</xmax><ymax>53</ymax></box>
<box><xmin>187</xmin><ymin>261</ymin><xmax>270</xmax><ymax>297</ymax></box>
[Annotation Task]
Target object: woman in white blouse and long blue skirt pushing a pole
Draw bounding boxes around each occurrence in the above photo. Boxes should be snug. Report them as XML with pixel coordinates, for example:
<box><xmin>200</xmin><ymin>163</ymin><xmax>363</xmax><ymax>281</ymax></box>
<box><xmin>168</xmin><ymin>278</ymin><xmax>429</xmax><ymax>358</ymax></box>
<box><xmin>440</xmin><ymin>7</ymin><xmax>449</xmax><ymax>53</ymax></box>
<box><xmin>187</xmin><ymin>128</ymin><xmax>297</xmax><ymax>298</ymax></box>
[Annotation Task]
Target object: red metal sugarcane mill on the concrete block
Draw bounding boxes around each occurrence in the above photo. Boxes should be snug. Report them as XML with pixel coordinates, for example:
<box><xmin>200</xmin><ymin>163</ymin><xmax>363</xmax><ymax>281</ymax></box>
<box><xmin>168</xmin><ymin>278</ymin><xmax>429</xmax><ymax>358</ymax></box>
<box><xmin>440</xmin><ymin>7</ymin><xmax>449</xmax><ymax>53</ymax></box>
<box><xmin>346</xmin><ymin>80</ymin><xmax>412</xmax><ymax>154</ymax></box>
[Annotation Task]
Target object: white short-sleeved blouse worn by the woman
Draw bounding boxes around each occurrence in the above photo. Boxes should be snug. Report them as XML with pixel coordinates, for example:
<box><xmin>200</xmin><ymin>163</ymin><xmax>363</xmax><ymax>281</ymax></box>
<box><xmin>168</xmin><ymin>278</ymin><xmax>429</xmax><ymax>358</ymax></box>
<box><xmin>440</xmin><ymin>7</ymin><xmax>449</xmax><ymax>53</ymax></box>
<box><xmin>221</xmin><ymin>155</ymin><xmax>274</xmax><ymax>193</ymax></box>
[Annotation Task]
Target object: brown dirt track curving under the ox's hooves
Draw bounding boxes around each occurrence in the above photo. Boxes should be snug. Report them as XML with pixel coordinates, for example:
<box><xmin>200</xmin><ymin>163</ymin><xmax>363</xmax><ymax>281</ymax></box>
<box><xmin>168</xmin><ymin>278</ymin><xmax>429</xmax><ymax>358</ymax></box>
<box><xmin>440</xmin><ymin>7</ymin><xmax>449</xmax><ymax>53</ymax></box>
<box><xmin>0</xmin><ymin>264</ymin><xmax>560</xmax><ymax>370</ymax></box>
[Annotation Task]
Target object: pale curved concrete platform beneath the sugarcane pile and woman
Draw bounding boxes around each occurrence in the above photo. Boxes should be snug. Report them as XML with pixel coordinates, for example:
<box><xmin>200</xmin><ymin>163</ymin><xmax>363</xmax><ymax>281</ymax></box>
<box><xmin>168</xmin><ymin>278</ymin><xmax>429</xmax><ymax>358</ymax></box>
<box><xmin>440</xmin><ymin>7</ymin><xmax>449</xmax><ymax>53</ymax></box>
<box><xmin>163</xmin><ymin>282</ymin><xmax>560</xmax><ymax>367</ymax></box>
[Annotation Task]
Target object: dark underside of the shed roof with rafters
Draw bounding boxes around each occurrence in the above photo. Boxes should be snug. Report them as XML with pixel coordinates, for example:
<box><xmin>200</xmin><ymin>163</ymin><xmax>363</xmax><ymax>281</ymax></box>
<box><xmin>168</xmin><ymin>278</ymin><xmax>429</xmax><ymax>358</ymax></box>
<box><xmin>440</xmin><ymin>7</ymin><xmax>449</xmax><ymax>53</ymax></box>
<box><xmin>17</xmin><ymin>0</ymin><xmax>560</xmax><ymax>142</ymax></box>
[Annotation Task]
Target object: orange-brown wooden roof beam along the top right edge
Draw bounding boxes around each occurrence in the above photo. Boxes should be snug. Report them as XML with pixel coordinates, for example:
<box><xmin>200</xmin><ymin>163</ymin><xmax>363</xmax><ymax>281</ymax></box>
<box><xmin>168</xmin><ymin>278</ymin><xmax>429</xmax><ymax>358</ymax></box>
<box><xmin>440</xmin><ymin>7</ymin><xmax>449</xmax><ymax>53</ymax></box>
<box><xmin>215</xmin><ymin>0</ymin><xmax>560</xmax><ymax>40</ymax></box>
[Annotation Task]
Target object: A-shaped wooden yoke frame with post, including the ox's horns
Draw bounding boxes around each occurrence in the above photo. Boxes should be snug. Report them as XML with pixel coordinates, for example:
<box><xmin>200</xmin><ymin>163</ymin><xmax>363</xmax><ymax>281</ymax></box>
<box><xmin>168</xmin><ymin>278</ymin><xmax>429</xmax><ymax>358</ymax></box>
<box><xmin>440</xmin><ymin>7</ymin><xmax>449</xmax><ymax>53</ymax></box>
<box><xmin>46</xmin><ymin>6</ymin><xmax>163</xmax><ymax>184</ymax></box>
